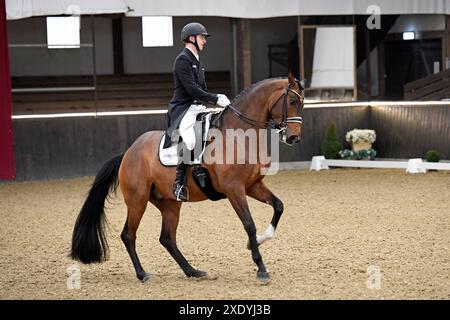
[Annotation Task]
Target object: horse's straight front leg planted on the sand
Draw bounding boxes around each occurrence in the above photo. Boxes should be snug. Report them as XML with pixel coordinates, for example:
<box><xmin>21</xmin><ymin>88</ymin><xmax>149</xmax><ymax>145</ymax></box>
<box><xmin>227</xmin><ymin>190</ymin><xmax>270</xmax><ymax>283</ymax></box>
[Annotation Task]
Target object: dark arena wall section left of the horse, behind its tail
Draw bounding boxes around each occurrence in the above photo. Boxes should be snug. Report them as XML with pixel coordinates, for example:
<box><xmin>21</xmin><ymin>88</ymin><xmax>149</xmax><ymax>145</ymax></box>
<box><xmin>13</xmin><ymin>115</ymin><xmax>166</xmax><ymax>180</ymax></box>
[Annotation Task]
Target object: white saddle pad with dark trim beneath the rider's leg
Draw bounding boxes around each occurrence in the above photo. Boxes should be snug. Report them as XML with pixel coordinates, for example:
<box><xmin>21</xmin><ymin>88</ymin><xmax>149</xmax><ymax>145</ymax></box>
<box><xmin>159</xmin><ymin>112</ymin><xmax>212</xmax><ymax>167</ymax></box>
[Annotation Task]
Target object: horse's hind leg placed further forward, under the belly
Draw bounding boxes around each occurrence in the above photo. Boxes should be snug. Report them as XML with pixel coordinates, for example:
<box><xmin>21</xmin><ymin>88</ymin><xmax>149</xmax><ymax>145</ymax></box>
<box><xmin>151</xmin><ymin>199</ymin><xmax>207</xmax><ymax>278</ymax></box>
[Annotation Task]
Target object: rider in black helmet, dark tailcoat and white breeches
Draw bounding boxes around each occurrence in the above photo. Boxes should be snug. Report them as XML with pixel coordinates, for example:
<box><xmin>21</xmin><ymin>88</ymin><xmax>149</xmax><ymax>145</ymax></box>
<box><xmin>164</xmin><ymin>22</ymin><xmax>230</xmax><ymax>201</ymax></box>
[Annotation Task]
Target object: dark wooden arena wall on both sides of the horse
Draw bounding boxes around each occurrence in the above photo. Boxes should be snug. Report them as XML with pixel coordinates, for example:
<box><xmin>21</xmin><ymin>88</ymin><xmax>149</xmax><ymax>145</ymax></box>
<box><xmin>13</xmin><ymin>105</ymin><xmax>450</xmax><ymax>180</ymax></box>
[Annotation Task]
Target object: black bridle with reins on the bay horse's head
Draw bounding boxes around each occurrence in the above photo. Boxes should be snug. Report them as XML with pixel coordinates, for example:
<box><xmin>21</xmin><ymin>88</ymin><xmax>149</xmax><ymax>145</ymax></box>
<box><xmin>226</xmin><ymin>84</ymin><xmax>304</xmax><ymax>142</ymax></box>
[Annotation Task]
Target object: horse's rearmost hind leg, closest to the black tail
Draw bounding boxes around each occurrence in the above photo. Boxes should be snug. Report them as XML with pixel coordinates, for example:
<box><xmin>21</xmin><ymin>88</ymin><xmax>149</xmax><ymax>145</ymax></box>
<box><xmin>120</xmin><ymin>200</ymin><xmax>150</xmax><ymax>282</ymax></box>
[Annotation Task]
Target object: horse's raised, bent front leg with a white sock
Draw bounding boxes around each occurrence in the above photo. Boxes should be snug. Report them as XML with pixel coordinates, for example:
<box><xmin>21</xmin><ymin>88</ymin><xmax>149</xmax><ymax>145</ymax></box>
<box><xmin>247</xmin><ymin>180</ymin><xmax>284</xmax><ymax>249</ymax></box>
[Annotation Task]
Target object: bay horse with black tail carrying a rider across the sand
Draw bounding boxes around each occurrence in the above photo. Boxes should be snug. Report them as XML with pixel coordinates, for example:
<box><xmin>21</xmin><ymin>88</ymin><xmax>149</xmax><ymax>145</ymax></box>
<box><xmin>70</xmin><ymin>74</ymin><xmax>304</xmax><ymax>283</ymax></box>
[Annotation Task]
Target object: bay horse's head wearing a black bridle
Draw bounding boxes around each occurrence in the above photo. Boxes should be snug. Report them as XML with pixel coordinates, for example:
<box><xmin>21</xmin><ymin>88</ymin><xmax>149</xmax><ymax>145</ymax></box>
<box><xmin>270</xmin><ymin>73</ymin><xmax>304</xmax><ymax>145</ymax></box>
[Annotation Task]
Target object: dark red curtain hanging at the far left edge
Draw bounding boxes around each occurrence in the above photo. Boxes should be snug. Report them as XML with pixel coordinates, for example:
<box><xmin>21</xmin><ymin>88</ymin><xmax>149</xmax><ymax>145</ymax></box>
<box><xmin>0</xmin><ymin>0</ymin><xmax>16</xmax><ymax>180</ymax></box>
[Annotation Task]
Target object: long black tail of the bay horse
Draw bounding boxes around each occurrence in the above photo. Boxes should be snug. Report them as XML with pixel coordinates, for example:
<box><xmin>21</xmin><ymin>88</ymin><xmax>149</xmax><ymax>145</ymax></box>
<box><xmin>70</xmin><ymin>154</ymin><xmax>123</xmax><ymax>263</ymax></box>
